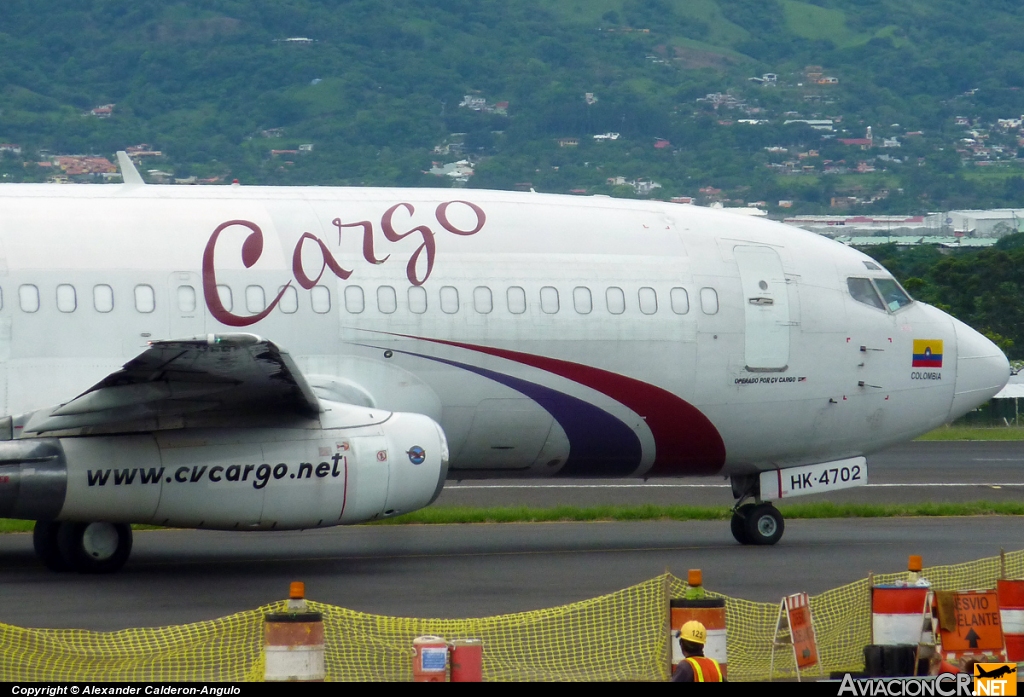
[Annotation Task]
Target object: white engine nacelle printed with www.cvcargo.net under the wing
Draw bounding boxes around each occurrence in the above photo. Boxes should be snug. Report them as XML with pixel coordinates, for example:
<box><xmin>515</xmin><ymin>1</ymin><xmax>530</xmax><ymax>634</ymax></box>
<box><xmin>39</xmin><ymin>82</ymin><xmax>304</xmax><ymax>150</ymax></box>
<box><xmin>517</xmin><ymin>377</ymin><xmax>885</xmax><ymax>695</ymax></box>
<box><xmin>0</xmin><ymin>410</ymin><xmax>449</xmax><ymax>530</ymax></box>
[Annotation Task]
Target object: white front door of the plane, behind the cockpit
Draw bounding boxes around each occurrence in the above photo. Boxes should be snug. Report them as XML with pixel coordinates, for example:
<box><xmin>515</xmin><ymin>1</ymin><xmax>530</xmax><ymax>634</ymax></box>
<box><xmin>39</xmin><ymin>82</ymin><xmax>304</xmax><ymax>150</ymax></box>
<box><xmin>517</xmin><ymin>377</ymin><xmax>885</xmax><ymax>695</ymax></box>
<box><xmin>733</xmin><ymin>245</ymin><xmax>791</xmax><ymax>373</ymax></box>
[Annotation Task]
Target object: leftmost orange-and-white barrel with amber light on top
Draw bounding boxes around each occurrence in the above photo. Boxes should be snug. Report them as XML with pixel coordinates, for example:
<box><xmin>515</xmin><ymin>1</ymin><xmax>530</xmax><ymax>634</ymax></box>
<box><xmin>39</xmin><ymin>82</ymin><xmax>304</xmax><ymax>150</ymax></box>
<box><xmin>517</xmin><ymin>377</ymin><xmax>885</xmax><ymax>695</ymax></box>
<box><xmin>263</xmin><ymin>581</ymin><xmax>327</xmax><ymax>683</ymax></box>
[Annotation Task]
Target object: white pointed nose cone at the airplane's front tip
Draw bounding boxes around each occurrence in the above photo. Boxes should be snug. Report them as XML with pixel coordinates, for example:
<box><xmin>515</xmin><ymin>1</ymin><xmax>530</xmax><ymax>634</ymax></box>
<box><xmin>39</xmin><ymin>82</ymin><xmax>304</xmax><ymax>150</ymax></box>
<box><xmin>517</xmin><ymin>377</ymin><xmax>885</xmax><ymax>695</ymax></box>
<box><xmin>949</xmin><ymin>319</ymin><xmax>1010</xmax><ymax>421</ymax></box>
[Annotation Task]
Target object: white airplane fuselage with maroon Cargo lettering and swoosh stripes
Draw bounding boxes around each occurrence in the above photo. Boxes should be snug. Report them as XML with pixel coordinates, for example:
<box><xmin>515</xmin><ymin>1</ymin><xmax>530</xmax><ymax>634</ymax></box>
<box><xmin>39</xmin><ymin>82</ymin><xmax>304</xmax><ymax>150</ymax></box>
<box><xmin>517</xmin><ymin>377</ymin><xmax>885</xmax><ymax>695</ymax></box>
<box><xmin>0</xmin><ymin>185</ymin><xmax>1008</xmax><ymax>477</ymax></box>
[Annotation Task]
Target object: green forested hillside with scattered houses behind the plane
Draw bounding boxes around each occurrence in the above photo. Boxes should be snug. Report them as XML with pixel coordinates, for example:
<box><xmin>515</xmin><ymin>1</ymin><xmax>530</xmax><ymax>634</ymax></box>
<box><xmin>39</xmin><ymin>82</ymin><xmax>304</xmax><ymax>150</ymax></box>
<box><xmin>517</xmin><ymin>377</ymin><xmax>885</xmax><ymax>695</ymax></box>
<box><xmin>0</xmin><ymin>0</ymin><xmax>1024</xmax><ymax>213</ymax></box>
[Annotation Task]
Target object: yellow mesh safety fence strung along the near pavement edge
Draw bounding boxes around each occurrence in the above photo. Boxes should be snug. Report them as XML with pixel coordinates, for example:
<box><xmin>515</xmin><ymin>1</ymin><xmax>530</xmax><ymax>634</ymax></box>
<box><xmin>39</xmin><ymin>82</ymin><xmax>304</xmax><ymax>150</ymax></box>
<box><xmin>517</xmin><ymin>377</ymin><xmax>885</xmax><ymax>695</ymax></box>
<box><xmin>0</xmin><ymin>551</ymin><xmax>1024</xmax><ymax>682</ymax></box>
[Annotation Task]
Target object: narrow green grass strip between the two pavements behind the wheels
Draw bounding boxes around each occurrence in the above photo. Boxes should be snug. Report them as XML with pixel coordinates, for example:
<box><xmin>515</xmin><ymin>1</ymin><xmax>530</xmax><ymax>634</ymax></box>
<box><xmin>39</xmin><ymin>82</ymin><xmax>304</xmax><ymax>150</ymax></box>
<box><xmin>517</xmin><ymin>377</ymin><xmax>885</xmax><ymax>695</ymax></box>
<box><xmin>0</xmin><ymin>500</ymin><xmax>1024</xmax><ymax>532</ymax></box>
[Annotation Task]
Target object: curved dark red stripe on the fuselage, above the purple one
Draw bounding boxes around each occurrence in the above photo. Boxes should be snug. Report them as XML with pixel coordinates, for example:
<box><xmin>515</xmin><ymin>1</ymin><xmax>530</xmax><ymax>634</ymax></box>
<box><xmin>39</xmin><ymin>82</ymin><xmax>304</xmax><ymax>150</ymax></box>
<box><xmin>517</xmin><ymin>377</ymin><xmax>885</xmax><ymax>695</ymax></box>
<box><xmin>381</xmin><ymin>332</ymin><xmax>725</xmax><ymax>475</ymax></box>
